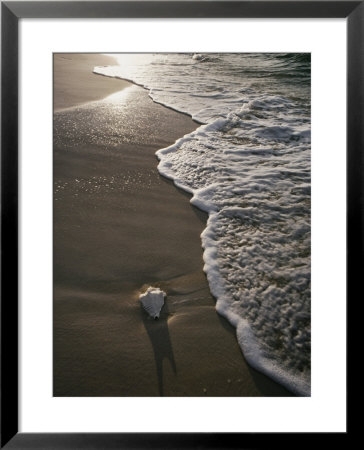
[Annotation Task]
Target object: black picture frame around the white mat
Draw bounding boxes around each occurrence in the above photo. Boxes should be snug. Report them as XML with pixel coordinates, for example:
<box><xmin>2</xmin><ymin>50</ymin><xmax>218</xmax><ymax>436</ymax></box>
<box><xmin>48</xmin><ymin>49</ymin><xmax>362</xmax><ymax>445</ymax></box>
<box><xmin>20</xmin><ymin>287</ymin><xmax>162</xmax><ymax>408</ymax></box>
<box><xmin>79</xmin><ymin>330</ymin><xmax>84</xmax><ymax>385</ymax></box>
<box><xmin>1</xmin><ymin>1</ymin><xmax>356</xmax><ymax>449</ymax></box>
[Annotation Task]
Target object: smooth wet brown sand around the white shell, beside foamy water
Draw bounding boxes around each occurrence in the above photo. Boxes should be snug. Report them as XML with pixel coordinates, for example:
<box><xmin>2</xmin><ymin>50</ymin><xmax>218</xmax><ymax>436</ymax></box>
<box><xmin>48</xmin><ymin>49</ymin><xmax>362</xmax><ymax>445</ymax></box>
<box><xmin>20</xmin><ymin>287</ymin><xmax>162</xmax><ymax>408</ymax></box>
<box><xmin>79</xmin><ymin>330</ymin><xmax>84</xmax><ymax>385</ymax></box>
<box><xmin>53</xmin><ymin>54</ymin><xmax>292</xmax><ymax>397</ymax></box>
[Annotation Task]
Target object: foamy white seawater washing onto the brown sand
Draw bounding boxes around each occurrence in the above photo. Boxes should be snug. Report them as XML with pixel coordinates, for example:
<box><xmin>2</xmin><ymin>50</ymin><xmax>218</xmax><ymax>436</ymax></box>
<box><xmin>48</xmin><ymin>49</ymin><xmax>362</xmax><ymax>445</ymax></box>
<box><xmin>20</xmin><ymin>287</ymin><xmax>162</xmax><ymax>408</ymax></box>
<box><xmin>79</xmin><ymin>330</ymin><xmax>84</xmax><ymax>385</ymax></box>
<box><xmin>94</xmin><ymin>53</ymin><xmax>311</xmax><ymax>395</ymax></box>
